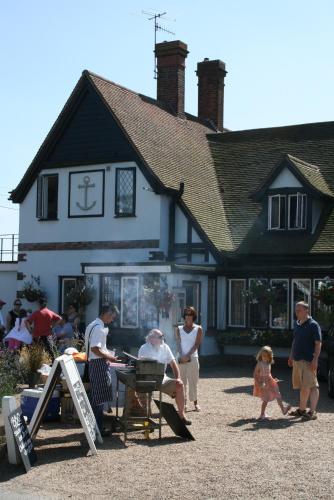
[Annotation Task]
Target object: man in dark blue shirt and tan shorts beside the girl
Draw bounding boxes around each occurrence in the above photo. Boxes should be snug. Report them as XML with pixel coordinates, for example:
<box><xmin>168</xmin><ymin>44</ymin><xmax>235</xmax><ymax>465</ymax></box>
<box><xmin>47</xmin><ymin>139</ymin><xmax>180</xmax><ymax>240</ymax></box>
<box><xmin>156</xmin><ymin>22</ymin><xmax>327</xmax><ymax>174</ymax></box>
<box><xmin>288</xmin><ymin>302</ymin><xmax>321</xmax><ymax>420</ymax></box>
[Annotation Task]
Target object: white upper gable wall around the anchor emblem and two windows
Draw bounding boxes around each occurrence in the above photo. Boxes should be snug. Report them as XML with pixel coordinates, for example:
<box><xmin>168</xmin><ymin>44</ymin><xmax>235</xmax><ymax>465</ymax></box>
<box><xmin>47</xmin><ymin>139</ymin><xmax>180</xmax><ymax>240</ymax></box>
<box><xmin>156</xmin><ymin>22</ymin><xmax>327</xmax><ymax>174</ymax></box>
<box><xmin>20</xmin><ymin>162</ymin><xmax>164</xmax><ymax>243</ymax></box>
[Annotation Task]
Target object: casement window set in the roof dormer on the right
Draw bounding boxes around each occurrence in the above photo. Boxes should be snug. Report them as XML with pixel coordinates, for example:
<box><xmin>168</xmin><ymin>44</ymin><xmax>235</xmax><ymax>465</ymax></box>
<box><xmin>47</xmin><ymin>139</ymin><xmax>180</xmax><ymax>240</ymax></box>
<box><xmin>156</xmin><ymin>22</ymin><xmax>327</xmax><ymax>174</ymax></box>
<box><xmin>268</xmin><ymin>192</ymin><xmax>307</xmax><ymax>230</ymax></box>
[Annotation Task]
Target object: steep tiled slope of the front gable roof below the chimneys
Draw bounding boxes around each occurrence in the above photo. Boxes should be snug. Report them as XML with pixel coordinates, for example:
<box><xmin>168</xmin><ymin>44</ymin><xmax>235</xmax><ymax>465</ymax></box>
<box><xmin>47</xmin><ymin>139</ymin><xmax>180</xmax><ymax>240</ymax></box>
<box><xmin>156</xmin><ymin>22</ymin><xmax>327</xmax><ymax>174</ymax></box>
<box><xmin>87</xmin><ymin>73</ymin><xmax>233</xmax><ymax>251</ymax></box>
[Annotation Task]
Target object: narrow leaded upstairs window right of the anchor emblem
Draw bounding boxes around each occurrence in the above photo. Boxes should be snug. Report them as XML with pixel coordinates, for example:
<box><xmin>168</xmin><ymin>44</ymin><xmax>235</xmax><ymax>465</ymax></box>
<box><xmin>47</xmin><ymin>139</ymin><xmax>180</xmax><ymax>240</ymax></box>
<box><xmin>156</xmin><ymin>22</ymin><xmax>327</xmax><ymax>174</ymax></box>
<box><xmin>115</xmin><ymin>168</ymin><xmax>136</xmax><ymax>217</ymax></box>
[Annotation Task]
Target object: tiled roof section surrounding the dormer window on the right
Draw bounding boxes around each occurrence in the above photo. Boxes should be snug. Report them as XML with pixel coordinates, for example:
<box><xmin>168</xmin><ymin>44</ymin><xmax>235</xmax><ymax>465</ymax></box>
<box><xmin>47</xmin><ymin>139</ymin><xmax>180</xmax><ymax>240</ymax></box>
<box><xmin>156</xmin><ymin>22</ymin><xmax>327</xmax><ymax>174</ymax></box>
<box><xmin>208</xmin><ymin>122</ymin><xmax>334</xmax><ymax>254</ymax></box>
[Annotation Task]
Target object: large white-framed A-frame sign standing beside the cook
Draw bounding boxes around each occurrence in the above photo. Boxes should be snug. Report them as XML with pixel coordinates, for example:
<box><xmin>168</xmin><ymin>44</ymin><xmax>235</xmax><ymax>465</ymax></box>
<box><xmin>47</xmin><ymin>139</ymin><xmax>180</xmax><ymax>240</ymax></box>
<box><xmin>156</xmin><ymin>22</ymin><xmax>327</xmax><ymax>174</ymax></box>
<box><xmin>29</xmin><ymin>354</ymin><xmax>103</xmax><ymax>455</ymax></box>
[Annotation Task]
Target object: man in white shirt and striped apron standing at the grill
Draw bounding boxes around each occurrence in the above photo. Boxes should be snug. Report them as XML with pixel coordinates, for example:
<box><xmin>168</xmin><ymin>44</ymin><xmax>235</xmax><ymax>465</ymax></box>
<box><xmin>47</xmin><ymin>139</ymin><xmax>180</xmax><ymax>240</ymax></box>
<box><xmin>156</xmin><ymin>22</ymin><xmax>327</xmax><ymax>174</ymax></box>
<box><xmin>85</xmin><ymin>306</ymin><xmax>118</xmax><ymax>436</ymax></box>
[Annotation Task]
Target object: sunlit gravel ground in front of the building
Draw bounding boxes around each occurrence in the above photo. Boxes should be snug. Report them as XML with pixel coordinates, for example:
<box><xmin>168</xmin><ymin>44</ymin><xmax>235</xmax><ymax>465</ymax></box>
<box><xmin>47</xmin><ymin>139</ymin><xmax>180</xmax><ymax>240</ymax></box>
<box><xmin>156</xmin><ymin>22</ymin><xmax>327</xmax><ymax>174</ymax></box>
<box><xmin>0</xmin><ymin>367</ymin><xmax>334</xmax><ymax>500</ymax></box>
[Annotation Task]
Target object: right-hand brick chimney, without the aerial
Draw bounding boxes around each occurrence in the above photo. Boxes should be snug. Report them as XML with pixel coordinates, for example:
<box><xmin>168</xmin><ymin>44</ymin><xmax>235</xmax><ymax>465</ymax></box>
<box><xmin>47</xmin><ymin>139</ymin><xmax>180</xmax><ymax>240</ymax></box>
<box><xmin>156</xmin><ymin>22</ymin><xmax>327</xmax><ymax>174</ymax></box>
<box><xmin>196</xmin><ymin>58</ymin><xmax>227</xmax><ymax>131</ymax></box>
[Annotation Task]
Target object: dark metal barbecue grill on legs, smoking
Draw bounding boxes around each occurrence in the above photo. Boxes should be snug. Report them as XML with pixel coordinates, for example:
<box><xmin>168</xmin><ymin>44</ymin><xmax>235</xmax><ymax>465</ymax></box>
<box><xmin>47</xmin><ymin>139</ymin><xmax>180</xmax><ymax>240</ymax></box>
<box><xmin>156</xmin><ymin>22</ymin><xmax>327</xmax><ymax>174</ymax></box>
<box><xmin>116</xmin><ymin>359</ymin><xmax>165</xmax><ymax>441</ymax></box>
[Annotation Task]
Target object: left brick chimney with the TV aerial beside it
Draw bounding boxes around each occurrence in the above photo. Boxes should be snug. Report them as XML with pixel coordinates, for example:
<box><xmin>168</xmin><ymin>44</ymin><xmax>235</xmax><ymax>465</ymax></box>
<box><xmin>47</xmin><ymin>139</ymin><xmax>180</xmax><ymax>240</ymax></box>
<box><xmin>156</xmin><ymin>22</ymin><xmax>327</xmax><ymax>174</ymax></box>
<box><xmin>155</xmin><ymin>40</ymin><xmax>188</xmax><ymax>116</ymax></box>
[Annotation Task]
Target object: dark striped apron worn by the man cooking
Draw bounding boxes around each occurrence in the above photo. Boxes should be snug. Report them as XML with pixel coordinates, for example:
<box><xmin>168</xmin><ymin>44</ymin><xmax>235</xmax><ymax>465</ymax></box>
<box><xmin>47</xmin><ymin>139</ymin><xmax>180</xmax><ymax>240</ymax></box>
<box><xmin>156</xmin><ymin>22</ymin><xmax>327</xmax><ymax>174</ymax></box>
<box><xmin>88</xmin><ymin>358</ymin><xmax>113</xmax><ymax>405</ymax></box>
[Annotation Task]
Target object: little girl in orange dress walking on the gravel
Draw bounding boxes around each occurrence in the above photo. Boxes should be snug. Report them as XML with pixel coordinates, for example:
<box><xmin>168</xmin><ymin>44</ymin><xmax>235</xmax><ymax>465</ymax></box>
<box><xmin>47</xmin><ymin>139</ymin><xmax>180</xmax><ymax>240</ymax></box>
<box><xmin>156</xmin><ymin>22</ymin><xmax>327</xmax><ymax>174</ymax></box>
<box><xmin>253</xmin><ymin>346</ymin><xmax>291</xmax><ymax>420</ymax></box>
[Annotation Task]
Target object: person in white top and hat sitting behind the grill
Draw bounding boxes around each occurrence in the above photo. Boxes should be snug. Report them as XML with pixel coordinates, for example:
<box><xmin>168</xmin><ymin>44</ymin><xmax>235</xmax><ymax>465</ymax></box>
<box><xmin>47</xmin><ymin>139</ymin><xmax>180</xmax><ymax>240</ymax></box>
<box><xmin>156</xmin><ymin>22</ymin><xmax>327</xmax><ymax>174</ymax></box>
<box><xmin>138</xmin><ymin>329</ymin><xmax>191</xmax><ymax>425</ymax></box>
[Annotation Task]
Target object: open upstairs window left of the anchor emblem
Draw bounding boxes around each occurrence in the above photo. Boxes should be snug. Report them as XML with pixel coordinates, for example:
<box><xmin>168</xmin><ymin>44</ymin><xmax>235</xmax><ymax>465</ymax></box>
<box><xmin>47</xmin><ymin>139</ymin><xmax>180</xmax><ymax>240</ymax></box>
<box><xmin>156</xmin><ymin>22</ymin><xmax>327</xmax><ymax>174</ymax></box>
<box><xmin>36</xmin><ymin>174</ymin><xmax>58</xmax><ymax>220</ymax></box>
